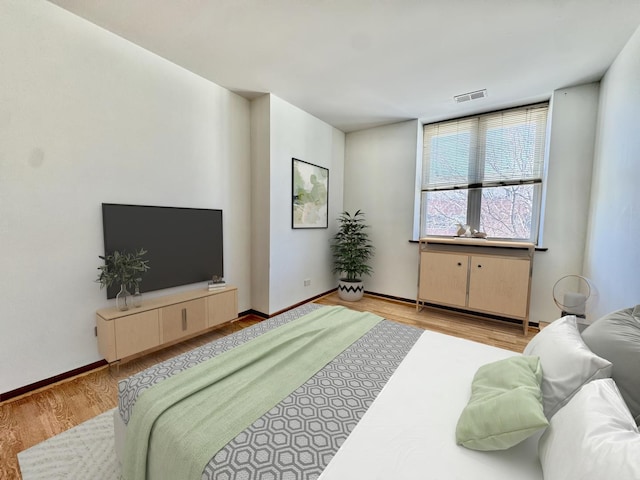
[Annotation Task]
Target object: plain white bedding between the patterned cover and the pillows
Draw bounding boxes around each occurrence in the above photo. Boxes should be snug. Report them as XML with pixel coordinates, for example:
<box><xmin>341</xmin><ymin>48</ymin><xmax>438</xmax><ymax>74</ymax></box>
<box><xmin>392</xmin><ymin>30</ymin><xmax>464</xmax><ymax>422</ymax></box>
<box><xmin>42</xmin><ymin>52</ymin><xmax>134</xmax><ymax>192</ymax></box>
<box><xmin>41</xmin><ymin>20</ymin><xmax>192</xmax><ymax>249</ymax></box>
<box><xmin>319</xmin><ymin>331</ymin><xmax>542</xmax><ymax>480</ymax></box>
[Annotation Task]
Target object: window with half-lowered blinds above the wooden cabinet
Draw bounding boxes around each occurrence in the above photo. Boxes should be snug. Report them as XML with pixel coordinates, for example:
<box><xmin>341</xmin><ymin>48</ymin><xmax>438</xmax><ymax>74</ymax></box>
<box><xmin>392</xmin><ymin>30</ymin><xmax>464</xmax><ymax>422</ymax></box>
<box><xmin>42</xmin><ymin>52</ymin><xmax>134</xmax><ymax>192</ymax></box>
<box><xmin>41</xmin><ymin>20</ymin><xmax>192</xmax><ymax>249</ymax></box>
<box><xmin>420</xmin><ymin>104</ymin><xmax>548</xmax><ymax>243</ymax></box>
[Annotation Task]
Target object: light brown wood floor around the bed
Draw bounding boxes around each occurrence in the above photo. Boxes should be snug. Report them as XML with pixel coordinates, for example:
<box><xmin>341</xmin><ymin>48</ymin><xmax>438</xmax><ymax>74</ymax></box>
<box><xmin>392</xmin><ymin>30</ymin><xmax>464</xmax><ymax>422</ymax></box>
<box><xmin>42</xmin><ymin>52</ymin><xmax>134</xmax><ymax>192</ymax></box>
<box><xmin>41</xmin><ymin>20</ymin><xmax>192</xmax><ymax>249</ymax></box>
<box><xmin>0</xmin><ymin>293</ymin><xmax>538</xmax><ymax>480</ymax></box>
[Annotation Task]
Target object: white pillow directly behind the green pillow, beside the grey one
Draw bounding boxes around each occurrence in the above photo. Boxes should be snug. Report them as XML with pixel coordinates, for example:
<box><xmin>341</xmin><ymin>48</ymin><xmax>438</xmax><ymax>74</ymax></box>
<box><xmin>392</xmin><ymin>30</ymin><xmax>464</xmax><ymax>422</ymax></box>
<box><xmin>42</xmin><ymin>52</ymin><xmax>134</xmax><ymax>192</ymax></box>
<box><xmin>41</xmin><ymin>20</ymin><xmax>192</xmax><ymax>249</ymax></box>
<box><xmin>523</xmin><ymin>315</ymin><xmax>612</xmax><ymax>419</ymax></box>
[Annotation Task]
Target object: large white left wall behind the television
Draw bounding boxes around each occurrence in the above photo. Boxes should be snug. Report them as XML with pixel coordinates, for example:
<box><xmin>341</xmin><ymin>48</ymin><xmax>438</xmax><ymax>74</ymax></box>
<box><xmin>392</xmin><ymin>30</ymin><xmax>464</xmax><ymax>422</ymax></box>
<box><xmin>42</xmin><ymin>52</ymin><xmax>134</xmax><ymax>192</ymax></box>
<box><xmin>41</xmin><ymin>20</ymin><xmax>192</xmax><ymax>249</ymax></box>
<box><xmin>0</xmin><ymin>0</ymin><xmax>251</xmax><ymax>392</ymax></box>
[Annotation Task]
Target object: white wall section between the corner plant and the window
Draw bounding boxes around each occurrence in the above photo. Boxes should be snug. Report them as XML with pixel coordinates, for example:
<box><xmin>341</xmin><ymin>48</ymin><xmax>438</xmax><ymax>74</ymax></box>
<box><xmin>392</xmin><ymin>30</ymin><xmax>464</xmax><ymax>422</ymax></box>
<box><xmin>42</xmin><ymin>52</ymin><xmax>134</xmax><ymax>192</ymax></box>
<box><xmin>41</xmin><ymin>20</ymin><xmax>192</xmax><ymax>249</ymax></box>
<box><xmin>344</xmin><ymin>120</ymin><xmax>421</xmax><ymax>299</ymax></box>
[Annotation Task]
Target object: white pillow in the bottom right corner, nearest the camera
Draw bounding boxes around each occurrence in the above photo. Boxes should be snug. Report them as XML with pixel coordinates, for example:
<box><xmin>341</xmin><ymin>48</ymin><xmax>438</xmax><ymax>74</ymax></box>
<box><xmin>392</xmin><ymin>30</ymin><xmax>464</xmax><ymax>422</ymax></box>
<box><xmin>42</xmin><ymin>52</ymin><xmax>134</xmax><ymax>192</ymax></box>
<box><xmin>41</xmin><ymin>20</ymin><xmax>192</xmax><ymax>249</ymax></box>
<box><xmin>538</xmin><ymin>378</ymin><xmax>640</xmax><ymax>480</ymax></box>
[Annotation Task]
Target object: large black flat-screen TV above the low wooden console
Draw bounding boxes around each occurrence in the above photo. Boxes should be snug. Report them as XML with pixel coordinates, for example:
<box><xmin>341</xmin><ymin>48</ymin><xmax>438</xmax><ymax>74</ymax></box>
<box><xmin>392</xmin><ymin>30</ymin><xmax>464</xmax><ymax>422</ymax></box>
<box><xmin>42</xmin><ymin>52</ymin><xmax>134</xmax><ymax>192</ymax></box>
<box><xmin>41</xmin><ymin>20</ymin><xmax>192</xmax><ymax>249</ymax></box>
<box><xmin>102</xmin><ymin>203</ymin><xmax>224</xmax><ymax>298</ymax></box>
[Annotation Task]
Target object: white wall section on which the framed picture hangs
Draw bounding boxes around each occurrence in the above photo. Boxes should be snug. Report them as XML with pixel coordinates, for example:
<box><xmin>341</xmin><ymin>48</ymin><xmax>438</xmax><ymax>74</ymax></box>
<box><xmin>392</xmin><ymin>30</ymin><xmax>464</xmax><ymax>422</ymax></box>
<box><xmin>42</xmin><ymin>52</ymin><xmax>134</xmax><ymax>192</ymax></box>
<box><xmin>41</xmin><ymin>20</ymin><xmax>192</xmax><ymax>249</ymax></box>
<box><xmin>268</xmin><ymin>95</ymin><xmax>345</xmax><ymax>314</ymax></box>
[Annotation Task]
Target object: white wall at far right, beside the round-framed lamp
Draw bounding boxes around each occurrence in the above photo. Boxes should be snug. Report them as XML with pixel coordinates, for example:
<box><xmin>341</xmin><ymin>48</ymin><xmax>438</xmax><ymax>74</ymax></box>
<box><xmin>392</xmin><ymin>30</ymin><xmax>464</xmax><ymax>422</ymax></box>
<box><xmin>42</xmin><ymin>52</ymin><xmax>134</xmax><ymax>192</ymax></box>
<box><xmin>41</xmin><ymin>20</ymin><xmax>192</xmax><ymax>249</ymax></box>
<box><xmin>584</xmin><ymin>28</ymin><xmax>640</xmax><ymax>318</ymax></box>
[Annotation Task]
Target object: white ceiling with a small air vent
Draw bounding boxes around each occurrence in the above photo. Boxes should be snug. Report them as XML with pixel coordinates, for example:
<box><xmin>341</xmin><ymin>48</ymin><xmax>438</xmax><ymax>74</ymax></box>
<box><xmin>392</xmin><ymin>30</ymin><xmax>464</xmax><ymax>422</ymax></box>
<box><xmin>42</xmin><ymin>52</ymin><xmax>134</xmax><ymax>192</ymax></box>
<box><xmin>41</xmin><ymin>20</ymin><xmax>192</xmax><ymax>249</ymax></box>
<box><xmin>50</xmin><ymin>0</ymin><xmax>640</xmax><ymax>132</ymax></box>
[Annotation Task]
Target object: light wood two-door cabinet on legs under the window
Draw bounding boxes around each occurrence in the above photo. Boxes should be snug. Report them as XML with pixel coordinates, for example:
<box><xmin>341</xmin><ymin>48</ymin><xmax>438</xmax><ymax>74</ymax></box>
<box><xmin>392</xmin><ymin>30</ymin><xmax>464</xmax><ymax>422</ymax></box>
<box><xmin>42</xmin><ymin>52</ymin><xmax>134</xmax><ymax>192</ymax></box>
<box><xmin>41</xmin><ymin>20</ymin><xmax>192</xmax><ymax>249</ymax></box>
<box><xmin>416</xmin><ymin>237</ymin><xmax>535</xmax><ymax>333</ymax></box>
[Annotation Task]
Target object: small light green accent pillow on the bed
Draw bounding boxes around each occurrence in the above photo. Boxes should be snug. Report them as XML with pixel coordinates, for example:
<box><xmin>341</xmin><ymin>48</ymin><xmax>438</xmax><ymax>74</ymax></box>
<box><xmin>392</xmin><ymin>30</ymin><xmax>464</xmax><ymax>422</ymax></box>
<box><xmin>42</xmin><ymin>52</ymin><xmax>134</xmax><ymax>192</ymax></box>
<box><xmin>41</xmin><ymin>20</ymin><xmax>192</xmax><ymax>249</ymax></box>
<box><xmin>456</xmin><ymin>356</ymin><xmax>549</xmax><ymax>450</ymax></box>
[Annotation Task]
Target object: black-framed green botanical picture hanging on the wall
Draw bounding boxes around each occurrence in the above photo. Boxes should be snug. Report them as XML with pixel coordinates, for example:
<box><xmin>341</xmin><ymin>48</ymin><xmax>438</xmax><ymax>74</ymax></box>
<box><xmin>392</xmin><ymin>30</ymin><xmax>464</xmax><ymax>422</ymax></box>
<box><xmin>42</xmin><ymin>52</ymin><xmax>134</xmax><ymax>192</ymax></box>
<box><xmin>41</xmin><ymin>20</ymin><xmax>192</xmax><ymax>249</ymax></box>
<box><xmin>291</xmin><ymin>158</ymin><xmax>329</xmax><ymax>229</ymax></box>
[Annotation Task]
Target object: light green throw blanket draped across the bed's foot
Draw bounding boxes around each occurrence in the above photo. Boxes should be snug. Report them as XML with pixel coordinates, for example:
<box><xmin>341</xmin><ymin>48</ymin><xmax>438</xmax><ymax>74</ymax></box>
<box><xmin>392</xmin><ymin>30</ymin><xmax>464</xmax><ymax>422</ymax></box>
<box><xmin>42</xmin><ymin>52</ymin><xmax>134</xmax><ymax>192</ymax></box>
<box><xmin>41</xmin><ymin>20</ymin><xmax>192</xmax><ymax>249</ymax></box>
<box><xmin>123</xmin><ymin>307</ymin><xmax>382</xmax><ymax>480</ymax></box>
